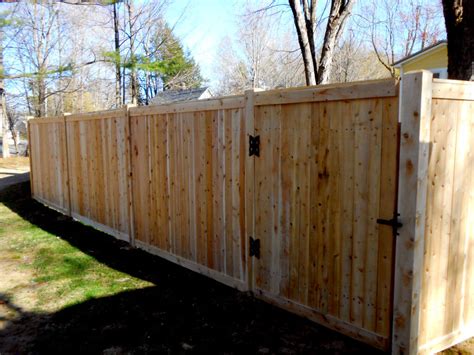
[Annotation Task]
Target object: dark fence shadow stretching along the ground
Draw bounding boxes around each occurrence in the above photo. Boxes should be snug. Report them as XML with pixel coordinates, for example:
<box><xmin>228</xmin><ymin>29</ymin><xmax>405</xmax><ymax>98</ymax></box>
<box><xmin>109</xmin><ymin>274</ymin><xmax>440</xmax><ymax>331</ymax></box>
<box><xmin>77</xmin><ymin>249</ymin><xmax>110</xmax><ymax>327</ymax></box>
<box><xmin>0</xmin><ymin>184</ymin><xmax>384</xmax><ymax>354</ymax></box>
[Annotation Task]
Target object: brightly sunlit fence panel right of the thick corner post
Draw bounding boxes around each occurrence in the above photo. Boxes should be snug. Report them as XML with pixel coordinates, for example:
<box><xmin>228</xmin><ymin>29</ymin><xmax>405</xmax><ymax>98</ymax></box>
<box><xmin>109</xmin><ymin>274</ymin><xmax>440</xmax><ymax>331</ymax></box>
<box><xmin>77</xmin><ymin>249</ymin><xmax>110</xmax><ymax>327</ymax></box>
<box><xmin>419</xmin><ymin>80</ymin><xmax>474</xmax><ymax>353</ymax></box>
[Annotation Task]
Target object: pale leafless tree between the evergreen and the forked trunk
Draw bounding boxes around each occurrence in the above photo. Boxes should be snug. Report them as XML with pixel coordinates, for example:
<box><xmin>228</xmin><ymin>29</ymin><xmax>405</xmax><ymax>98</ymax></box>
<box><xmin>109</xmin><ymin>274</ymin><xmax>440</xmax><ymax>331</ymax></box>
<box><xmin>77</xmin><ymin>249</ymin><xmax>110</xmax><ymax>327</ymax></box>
<box><xmin>216</xmin><ymin>5</ymin><xmax>305</xmax><ymax>95</ymax></box>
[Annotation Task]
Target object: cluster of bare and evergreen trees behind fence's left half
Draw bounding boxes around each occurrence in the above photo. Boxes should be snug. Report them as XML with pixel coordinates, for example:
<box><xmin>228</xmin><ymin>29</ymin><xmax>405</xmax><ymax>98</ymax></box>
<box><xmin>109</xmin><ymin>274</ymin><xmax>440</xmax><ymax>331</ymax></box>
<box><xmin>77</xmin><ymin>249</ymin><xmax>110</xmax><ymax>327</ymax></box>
<box><xmin>0</xmin><ymin>0</ymin><xmax>203</xmax><ymax>121</ymax></box>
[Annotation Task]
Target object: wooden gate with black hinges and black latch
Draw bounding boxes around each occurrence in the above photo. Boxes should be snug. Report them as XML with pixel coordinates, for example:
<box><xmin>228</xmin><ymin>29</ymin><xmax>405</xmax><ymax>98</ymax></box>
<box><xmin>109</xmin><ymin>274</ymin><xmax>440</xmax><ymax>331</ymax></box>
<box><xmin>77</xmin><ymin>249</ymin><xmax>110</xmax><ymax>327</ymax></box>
<box><xmin>251</xmin><ymin>84</ymin><xmax>398</xmax><ymax>348</ymax></box>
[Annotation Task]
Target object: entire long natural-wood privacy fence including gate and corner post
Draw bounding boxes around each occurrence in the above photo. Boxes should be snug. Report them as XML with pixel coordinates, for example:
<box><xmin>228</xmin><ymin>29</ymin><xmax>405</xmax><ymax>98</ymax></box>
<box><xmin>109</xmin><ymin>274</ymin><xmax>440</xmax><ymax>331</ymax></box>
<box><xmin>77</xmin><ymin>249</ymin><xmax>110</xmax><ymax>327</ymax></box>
<box><xmin>28</xmin><ymin>72</ymin><xmax>474</xmax><ymax>354</ymax></box>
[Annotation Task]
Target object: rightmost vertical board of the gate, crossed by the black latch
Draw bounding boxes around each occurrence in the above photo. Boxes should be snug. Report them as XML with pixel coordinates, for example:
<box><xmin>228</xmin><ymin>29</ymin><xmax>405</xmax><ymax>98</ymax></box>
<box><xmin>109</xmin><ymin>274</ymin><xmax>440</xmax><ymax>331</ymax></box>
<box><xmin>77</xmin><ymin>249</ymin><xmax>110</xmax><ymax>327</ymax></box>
<box><xmin>376</xmin><ymin>98</ymin><xmax>398</xmax><ymax>337</ymax></box>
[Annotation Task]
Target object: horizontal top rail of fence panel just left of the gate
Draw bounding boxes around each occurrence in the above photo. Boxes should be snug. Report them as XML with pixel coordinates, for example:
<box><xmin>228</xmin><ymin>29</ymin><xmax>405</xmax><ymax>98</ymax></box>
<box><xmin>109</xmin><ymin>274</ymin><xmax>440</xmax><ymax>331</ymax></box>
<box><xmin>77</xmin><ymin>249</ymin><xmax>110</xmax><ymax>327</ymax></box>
<box><xmin>130</xmin><ymin>95</ymin><xmax>245</xmax><ymax>116</ymax></box>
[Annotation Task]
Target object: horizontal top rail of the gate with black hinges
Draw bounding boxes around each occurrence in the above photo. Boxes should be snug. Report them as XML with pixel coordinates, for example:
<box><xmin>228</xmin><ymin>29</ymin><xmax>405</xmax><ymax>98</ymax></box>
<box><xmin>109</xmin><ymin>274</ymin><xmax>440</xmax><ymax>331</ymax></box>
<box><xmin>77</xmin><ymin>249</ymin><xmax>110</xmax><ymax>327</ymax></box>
<box><xmin>255</xmin><ymin>79</ymin><xmax>398</xmax><ymax>106</ymax></box>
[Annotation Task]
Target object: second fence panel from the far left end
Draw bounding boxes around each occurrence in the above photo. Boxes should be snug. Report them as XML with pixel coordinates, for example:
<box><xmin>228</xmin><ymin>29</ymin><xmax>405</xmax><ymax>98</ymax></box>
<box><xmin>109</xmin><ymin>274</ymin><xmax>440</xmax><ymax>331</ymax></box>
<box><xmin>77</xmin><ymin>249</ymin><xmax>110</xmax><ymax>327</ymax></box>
<box><xmin>66</xmin><ymin>109</ymin><xmax>130</xmax><ymax>241</ymax></box>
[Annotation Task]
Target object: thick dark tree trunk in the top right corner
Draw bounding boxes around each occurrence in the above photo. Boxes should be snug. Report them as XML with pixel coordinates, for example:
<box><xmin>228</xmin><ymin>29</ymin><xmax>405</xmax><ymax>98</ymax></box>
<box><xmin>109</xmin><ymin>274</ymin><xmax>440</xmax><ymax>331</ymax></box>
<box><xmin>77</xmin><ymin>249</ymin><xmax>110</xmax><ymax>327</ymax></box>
<box><xmin>443</xmin><ymin>0</ymin><xmax>474</xmax><ymax>80</ymax></box>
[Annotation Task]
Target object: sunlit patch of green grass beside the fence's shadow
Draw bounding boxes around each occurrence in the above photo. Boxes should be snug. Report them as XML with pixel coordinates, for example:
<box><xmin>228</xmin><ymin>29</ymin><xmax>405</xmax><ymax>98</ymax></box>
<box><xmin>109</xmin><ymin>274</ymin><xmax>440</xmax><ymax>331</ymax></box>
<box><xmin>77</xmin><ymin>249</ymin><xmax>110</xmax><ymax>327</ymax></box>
<box><xmin>0</xmin><ymin>185</ymin><xmax>151</xmax><ymax>311</ymax></box>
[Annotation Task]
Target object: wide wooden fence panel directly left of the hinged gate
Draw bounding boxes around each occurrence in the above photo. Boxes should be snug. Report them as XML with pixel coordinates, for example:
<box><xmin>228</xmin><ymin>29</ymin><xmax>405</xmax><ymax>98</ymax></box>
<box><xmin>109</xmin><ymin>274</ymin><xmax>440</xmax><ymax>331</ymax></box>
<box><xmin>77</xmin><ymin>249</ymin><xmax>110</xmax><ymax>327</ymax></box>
<box><xmin>130</xmin><ymin>97</ymin><xmax>247</xmax><ymax>289</ymax></box>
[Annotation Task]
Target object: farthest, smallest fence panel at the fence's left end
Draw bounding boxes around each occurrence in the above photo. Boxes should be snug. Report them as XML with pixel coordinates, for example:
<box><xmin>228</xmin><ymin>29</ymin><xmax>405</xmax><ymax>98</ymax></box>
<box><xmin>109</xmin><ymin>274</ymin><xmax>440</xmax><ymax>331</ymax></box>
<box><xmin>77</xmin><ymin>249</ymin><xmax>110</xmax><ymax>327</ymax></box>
<box><xmin>28</xmin><ymin>117</ymin><xmax>69</xmax><ymax>214</ymax></box>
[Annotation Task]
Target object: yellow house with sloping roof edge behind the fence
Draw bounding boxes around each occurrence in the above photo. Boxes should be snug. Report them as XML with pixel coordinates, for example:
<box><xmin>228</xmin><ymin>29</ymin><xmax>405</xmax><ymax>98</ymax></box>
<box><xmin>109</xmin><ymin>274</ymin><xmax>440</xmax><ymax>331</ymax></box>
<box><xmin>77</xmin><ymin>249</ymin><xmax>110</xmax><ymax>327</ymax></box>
<box><xmin>392</xmin><ymin>40</ymin><xmax>448</xmax><ymax>79</ymax></box>
